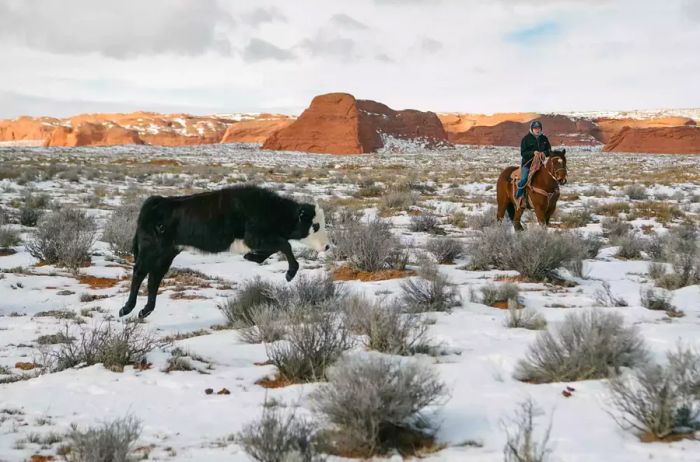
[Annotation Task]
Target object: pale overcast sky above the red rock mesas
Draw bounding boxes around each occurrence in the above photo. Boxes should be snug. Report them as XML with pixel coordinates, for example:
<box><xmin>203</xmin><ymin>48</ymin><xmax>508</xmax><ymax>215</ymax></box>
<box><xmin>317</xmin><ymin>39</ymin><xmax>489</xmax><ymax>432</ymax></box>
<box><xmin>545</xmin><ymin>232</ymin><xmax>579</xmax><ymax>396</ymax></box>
<box><xmin>0</xmin><ymin>0</ymin><xmax>700</xmax><ymax>117</ymax></box>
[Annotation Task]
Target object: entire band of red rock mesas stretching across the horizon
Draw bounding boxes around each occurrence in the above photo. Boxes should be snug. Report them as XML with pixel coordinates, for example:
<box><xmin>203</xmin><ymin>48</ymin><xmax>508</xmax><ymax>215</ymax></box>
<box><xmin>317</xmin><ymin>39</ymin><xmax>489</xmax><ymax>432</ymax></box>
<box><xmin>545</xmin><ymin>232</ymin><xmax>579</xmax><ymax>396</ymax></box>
<box><xmin>0</xmin><ymin>99</ymin><xmax>700</xmax><ymax>154</ymax></box>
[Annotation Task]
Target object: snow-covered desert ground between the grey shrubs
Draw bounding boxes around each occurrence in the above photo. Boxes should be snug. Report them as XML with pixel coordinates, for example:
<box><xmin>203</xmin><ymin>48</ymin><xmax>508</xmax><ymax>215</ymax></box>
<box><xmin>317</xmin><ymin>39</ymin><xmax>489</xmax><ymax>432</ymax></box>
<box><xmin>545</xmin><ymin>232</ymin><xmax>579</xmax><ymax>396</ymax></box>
<box><xmin>0</xmin><ymin>145</ymin><xmax>700</xmax><ymax>462</ymax></box>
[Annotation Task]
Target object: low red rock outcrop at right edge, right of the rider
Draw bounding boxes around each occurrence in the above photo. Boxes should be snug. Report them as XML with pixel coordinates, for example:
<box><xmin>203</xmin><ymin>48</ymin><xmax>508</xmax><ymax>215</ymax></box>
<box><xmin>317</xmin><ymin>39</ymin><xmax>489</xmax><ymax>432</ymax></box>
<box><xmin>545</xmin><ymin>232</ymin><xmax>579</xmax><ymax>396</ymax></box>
<box><xmin>603</xmin><ymin>125</ymin><xmax>700</xmax><ymax>154</ymax></box>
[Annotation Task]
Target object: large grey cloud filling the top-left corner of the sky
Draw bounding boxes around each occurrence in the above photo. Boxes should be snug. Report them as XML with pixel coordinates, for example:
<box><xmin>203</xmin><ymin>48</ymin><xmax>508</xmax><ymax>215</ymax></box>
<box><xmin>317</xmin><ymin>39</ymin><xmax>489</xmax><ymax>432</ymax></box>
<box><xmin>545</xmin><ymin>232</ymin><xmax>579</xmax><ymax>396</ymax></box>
<box><xmin>0</xmin><ymin>0</ymin><xmax>234</xmax><ymax>59</ymax></box>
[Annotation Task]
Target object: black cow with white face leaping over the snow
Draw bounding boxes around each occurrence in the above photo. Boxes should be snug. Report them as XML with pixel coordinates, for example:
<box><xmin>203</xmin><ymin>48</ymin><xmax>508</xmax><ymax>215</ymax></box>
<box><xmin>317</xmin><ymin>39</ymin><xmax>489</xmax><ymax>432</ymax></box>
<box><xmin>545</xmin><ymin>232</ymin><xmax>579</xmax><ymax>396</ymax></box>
<box><xmin>119</xmin><ymin>185</ymin><xmax>329</xmax><ymax>318</ymax></box>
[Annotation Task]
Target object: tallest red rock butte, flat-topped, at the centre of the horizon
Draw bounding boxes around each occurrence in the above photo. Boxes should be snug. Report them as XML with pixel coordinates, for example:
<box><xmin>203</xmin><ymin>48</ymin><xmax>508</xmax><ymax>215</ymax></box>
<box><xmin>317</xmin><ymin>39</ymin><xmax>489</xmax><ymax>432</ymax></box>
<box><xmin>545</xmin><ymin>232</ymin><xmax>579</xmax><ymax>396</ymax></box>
<box><xmin>263</xmin><ymin>93</ymin><xmax>448</xmax><ymax>154</ymax></box>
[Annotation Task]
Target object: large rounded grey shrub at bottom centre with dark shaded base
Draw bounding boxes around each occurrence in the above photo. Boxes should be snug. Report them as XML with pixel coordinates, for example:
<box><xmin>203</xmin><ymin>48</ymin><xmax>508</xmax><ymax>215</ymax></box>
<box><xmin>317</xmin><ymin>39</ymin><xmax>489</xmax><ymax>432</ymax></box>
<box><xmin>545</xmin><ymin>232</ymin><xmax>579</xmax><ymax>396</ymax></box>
<box><xmin>311</xmin><ymin>354</ymin><xmax>447</xmax><ymax>457</ymax></box>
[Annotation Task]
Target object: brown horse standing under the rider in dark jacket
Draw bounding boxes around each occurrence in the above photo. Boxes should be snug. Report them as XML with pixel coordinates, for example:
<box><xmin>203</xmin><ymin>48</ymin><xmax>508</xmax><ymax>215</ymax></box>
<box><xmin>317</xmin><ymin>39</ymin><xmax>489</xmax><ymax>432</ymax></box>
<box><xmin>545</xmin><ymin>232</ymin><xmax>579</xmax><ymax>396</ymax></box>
<box><xmin>496</xmin><ymin>149</ymin><xmax>567</xmax><ymax>231</ymax></box>
